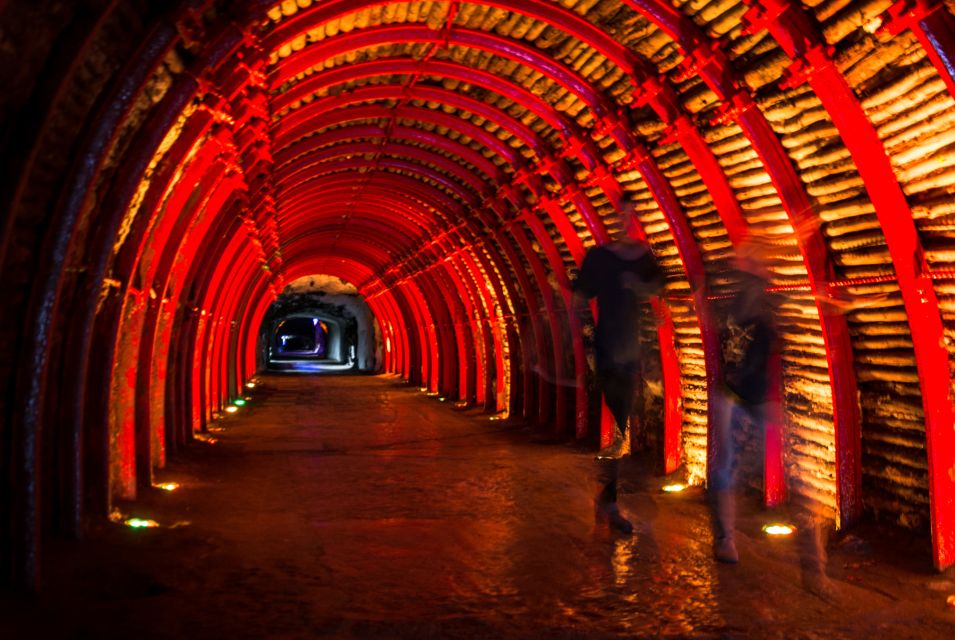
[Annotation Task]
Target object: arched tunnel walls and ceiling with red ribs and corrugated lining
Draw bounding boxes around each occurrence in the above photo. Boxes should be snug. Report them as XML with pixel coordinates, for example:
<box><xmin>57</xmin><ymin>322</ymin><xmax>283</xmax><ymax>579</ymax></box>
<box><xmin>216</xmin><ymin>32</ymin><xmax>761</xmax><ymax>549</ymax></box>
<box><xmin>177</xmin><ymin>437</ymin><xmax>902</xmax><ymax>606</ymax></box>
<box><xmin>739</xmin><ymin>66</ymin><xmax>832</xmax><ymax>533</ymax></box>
<box><xmin>0</xmin><ymin>0</ymin><xmax>955</xmax><ymax>620</ymax></box>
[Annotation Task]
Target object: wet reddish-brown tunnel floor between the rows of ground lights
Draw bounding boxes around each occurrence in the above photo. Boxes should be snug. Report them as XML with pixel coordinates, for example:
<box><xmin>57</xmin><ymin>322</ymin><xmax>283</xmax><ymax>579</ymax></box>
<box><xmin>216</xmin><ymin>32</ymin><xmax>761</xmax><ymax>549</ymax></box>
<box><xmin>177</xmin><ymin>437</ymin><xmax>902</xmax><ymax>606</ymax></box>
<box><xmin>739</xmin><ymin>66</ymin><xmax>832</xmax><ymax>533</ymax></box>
<box><xmin>0</xmin><ymin>375</ymin><xmax>955</xmax><ymax>639</ymax></box>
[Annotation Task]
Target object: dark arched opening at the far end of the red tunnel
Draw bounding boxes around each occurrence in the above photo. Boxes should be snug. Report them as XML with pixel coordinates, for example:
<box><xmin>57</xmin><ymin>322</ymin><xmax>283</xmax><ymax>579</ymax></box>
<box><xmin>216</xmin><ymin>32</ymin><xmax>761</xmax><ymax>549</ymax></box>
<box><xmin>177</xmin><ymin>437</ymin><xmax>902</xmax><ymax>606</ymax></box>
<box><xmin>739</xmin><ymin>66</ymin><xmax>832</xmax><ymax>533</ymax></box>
<box><xmin>258</xmin><ymin>275</ymin><xmax>382</xmax><ymax>373</ymax></box>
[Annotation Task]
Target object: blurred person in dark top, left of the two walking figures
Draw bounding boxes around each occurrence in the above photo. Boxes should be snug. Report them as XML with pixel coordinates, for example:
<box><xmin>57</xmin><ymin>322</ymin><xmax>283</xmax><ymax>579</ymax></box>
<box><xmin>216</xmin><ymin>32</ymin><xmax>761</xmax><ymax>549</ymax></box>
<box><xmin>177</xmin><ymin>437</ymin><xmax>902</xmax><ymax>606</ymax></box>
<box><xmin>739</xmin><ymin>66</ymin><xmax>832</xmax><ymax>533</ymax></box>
<box><xmin>574</xmin><ymin>211</ymin><xmax>663</xmax><ymax>533</ymax></box>
